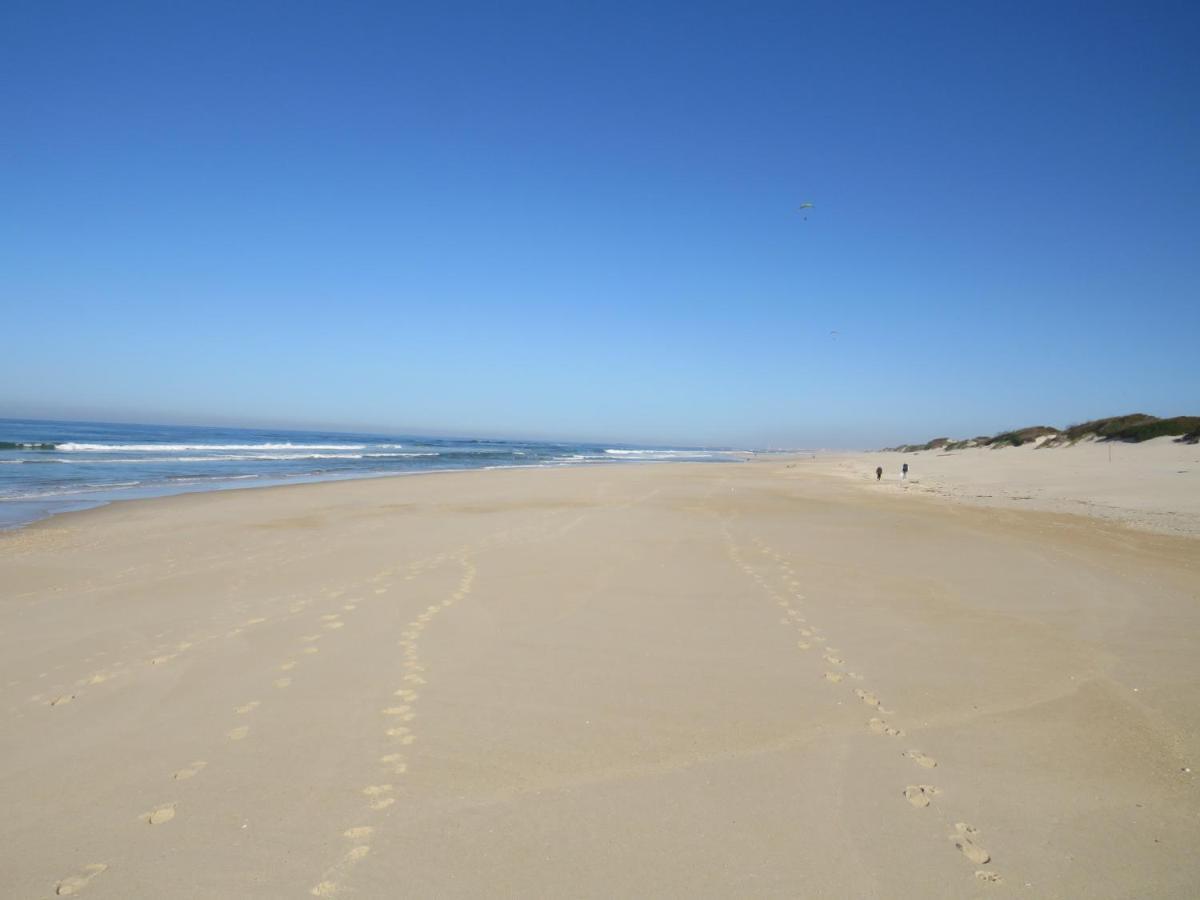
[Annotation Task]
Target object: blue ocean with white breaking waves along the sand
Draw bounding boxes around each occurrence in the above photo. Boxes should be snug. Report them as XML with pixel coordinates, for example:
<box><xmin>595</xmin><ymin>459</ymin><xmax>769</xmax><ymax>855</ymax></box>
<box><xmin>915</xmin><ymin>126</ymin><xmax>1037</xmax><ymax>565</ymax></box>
<box><xmin>0</xmin><ymin>419</ymin><xmax>751</xmax><ymax>528</ymax></box>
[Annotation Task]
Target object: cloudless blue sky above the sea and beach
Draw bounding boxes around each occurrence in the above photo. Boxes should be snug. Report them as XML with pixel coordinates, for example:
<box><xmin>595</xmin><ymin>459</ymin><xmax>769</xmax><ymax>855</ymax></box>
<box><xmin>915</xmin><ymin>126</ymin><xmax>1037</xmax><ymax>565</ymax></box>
<box><xmin>0</xmin><ymin>0</ymin><xmax>1200</xmax><ymax>446</ymax></box>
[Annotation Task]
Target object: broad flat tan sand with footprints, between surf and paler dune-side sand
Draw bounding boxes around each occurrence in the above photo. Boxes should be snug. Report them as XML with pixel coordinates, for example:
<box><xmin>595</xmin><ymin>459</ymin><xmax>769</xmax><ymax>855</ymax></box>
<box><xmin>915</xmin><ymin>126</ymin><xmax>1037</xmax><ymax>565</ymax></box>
<box><xmin>0</xmin><ymin>455</ymin><xmax>1200</xmax><ymax>899</ymax></box>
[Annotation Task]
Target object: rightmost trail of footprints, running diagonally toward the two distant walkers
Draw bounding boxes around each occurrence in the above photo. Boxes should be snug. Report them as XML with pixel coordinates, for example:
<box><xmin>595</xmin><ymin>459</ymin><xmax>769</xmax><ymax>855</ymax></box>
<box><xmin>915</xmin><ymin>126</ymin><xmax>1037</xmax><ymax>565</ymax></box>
<box><xmin>722</xmin><ymin>524</ymin><xmax>1002</xmax><ymax>884</ymax></box>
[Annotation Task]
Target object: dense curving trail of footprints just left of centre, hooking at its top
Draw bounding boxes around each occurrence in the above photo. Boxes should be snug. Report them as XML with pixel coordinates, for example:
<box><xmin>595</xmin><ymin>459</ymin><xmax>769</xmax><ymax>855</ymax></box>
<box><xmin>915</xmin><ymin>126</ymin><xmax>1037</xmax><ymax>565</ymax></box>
<box><xmin>310</xmin><ymin>551</ymin><xmax>476</xmax><ymax>896</ymax></box>
